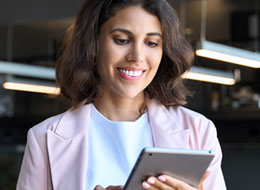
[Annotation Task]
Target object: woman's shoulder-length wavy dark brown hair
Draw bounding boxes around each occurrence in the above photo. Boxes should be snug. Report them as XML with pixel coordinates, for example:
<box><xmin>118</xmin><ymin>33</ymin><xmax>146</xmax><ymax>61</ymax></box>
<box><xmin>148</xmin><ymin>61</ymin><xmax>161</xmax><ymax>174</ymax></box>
<box><xmin>56</xmin><ymin>0</ymin><xmax>194</xmax><ymax>108</ymax></box>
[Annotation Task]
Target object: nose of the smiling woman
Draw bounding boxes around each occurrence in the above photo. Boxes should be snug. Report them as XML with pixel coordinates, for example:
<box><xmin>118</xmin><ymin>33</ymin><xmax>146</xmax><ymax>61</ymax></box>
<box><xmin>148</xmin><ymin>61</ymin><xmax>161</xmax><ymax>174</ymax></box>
<box><xmin>126</xmin><ymin>43</ymin><xmax>145</xmax><ymax>63</ymax></box>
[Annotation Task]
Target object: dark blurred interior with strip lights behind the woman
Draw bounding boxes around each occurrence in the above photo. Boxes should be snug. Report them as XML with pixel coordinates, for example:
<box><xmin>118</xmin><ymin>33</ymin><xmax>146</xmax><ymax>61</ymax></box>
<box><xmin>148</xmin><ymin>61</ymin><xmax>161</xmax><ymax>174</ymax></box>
<box><xmin>0</xmin><ymin>0</ymin><xmax>260</xmax><ymax>190</ymax></box>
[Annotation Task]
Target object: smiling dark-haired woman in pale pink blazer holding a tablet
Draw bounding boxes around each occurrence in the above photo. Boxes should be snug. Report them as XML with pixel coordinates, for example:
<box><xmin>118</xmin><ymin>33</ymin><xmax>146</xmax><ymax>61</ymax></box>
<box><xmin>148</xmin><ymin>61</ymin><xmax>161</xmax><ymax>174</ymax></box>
<box><xmin>17</xmin><ymin>0</ymin><xmax>225</xmax><ymax>190</ymax></box>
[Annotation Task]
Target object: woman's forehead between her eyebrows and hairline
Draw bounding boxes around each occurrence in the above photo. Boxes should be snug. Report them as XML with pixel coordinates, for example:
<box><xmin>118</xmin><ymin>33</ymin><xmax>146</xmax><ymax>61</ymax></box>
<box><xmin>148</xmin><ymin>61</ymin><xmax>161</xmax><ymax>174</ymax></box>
<box><xmin>101</xmin><ymin>6</ymin><xmax>162</xmax><ymax>34</ymax></box>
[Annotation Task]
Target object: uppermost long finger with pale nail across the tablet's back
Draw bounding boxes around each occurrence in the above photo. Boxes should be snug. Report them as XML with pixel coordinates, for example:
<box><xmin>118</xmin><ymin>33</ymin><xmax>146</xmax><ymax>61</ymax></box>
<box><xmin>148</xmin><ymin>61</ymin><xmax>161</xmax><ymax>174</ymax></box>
<box><xmin>158</xmin><ymin>175</ymin><xmax>195</xmax><ymax>190</ymax></box>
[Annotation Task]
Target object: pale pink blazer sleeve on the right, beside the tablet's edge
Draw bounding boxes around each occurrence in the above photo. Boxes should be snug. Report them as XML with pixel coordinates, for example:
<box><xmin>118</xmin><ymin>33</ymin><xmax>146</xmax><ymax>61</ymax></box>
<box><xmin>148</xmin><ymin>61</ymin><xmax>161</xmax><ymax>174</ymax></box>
<box><xmin>201</xmin><ymin>119</ymin><xmax>226</xmax><ymax>190</ymax></box>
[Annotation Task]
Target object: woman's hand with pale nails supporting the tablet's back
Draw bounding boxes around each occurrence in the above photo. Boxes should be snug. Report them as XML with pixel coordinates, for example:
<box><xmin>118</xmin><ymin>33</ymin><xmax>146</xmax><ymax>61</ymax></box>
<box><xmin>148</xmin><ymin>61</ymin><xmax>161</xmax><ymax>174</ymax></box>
<box><xmin>142</xmin><ymin>171</ymin><xmax>209</xmax><ymax>190</ymax></box>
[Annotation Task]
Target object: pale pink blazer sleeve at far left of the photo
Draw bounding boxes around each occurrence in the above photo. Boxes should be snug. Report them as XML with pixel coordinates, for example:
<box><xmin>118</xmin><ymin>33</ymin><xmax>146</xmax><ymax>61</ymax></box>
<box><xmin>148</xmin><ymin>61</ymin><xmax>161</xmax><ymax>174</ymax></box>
<box><xmin>16</xmin><ymin>128</ymin><xmax>51</xmax><ymax>190</ymax></box>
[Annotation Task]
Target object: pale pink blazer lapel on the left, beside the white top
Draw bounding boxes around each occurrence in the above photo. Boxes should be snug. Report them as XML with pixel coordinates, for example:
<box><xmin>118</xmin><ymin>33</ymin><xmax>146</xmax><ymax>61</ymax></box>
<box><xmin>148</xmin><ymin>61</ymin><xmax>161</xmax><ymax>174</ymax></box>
<box><xmin>47</xmin><ymin>105</ymin><xmax>90</xmax><ymax>190</ymax></box>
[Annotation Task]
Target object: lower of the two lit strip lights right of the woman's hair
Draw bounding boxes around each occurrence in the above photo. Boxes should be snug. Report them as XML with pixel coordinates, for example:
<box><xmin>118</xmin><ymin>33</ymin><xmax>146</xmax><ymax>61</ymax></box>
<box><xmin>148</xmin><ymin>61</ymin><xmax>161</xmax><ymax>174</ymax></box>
<box><xmin>182</xmin><ymin>66</ymin><xmax>236</xmax><ymax>85</ymax></box>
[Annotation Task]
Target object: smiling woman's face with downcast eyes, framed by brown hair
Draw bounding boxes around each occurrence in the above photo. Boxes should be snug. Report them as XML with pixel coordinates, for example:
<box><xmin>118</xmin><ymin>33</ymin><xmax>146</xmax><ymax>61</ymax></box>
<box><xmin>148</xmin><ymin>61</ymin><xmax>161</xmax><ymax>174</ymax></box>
<box><xmin>97</xmin><ymin>6</ymin><xmax>163</xmax><ymax>98</ymax></box>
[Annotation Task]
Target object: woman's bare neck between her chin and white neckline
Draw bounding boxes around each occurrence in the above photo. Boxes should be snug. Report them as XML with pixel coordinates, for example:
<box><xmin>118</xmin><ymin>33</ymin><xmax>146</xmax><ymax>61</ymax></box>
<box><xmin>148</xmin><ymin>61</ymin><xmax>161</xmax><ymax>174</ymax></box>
<box><xmin>94</xmin><ymin>93</ymin><xmax>144</xmax><ymax>121</ymax></box>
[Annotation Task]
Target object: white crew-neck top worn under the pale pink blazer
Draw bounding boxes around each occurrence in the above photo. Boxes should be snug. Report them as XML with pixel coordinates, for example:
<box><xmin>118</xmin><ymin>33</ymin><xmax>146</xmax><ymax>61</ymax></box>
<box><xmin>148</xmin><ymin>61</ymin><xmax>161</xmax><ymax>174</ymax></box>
<box><xmin>86</xmin><ymin>105</ymin><xmax>154</xmax><ymax>190</ymax></box>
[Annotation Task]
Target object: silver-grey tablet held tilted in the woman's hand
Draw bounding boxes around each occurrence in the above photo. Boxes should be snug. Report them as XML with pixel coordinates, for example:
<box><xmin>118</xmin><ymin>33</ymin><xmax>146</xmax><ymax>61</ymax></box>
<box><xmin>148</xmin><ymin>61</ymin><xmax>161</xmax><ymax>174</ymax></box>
<box><xmin>124</xmin><ymin>148</ymin><xmax>214</xmax><ymax>190</ymax></box>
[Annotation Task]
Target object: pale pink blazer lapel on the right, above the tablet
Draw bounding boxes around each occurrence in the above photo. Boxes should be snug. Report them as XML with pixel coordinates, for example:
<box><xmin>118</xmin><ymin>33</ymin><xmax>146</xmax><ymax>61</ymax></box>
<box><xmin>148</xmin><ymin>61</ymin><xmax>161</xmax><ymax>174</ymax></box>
<box><xmin>148</xmin><ymin>101</ymin><xmax>189</xmax><ymax>149</ymax></box>
